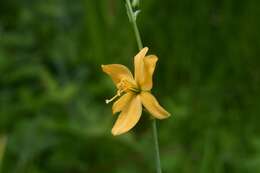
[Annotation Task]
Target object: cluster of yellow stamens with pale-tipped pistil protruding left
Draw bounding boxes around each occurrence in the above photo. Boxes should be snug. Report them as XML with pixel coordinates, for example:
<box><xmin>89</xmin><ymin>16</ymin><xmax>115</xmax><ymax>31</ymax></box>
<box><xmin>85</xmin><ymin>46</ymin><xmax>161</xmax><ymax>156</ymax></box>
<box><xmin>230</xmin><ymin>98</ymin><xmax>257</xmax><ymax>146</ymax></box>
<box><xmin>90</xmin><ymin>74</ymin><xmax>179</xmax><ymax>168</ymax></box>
<box><xmin>106</xmin><ymin>79</ymin><xmax>140</xmax><ymax>104</ymax></box>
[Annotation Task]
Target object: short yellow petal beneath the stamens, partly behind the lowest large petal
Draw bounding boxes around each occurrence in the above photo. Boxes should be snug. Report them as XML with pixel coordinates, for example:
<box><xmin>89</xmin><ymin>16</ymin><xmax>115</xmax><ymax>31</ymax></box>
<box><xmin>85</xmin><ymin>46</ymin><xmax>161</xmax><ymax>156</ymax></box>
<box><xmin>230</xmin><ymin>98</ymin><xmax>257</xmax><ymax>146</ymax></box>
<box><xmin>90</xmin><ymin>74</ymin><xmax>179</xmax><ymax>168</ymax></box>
<box><xmin>112</xmin><ymin>92</ymin><xmax>134</xmax><ymax>114</ymax></box>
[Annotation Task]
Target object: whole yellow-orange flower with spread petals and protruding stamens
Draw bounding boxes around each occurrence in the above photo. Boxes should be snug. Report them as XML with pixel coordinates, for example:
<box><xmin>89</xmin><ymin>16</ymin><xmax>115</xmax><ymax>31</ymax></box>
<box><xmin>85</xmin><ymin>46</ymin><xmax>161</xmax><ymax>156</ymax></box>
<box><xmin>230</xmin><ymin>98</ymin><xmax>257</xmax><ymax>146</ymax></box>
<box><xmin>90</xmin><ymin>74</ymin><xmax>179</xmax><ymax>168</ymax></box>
<box><xmin>102</xmin><ymin>47</ymin><xmax>170</xmax><ymax>135</ymax></box>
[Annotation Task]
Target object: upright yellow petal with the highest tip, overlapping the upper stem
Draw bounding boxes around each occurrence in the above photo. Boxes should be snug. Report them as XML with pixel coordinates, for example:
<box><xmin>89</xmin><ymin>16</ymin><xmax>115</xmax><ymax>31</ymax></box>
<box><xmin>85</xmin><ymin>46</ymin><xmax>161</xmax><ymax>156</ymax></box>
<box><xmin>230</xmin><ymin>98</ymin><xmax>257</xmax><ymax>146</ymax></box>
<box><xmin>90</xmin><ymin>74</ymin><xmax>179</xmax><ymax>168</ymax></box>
<box><xmin>134</xmin><ymin>47</ymin><xmax>148</xmax><ymax>85</ymax></box>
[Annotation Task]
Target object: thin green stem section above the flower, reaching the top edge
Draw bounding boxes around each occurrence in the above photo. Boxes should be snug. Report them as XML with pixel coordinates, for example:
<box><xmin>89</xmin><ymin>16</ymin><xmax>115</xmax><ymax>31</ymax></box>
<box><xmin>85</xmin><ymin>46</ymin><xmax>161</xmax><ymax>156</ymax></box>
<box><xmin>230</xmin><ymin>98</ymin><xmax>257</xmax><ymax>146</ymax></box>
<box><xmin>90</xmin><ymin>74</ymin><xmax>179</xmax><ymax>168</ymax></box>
<box><xmin>126</xmin><ymin>0</ymin><xmax>143</xmax><ymax>50</ymax></box>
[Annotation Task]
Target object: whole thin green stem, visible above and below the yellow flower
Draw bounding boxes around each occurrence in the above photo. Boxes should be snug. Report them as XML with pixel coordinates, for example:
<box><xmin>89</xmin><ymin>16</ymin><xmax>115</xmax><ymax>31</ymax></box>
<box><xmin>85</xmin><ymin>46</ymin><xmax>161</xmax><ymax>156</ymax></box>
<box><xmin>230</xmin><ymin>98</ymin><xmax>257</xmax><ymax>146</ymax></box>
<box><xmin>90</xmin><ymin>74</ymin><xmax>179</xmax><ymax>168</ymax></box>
<box><xmin>126</xmin><ymin>0</ymin><xmax>162</xmax><ymax>173</ymax></box>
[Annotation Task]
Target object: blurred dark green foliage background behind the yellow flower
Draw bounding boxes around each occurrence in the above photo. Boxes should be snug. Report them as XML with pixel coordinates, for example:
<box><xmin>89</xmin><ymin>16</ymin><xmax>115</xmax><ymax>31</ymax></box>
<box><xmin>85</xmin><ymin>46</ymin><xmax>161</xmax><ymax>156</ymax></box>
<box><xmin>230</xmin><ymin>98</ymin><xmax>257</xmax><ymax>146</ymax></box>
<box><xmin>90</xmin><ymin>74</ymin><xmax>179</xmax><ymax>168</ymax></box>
<box><xmin>0</xmin><ymin>0</ymin><xmax>260</xmax><ymax>173</ymax></box>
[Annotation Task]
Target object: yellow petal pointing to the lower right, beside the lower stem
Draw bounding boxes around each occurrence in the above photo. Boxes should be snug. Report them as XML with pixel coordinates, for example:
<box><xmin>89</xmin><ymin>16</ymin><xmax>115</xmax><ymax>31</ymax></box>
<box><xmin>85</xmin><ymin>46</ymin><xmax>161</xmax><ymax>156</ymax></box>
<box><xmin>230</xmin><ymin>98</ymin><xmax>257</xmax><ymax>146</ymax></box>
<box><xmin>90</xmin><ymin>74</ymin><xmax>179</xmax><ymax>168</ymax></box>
<box><xmin>140</xmin><ymin>92</ymin><xmax>170</xmax><ymax>119</ymax></box>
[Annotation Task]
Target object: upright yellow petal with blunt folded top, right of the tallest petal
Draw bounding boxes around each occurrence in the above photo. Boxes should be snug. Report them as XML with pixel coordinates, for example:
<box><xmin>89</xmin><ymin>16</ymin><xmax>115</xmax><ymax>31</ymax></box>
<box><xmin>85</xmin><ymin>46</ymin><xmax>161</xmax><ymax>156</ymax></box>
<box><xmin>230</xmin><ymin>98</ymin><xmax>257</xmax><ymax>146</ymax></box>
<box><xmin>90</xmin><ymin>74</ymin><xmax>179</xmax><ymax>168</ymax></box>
<box><xmin>140</xmin><ymin>55</ymin><xmax>158</xmax><ymax>91</ymax></box>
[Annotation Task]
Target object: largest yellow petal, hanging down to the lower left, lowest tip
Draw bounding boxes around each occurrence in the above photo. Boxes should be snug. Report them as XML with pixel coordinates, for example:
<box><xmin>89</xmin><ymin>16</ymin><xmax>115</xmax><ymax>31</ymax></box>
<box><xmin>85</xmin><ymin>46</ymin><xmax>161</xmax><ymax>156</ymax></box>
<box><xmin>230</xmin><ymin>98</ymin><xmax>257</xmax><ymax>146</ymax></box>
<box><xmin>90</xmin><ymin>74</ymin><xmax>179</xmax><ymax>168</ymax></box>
<box><xmin>111</xmin><ymin>95</ymin><xmax>142</xmax><ymax>136</ymax></box>
